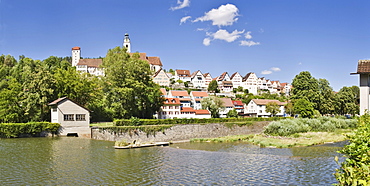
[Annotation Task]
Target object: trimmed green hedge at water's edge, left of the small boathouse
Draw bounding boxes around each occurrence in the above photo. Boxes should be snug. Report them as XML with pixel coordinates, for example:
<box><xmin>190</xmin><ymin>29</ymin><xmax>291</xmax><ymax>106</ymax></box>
<box><xmin>0</xmin><ymin>122</ymin><xmax>60</xmax><ymax>138</ymax></box>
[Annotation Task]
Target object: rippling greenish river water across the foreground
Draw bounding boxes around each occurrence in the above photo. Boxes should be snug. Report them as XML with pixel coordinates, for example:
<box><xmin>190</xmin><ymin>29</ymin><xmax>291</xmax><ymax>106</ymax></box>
<box><xmin>0</xmin><ymin>137</ymin><xmax>343</xmax><ymax>185</ymax></box>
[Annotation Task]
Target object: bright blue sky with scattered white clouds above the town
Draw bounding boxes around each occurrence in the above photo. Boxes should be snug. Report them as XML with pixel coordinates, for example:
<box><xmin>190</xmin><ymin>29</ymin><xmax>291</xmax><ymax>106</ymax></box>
<box><xmin>0</xmin><ymin>0</ymin><xmax>370</xmax><ymax>91</ymax></box>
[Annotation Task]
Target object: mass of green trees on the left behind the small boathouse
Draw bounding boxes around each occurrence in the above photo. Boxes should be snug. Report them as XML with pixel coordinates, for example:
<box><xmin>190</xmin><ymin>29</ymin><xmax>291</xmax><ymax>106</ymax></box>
<box><xmin>0</xmin><ymin>47</ymin><xmax>163</xmax><ymax>123</ymax></box>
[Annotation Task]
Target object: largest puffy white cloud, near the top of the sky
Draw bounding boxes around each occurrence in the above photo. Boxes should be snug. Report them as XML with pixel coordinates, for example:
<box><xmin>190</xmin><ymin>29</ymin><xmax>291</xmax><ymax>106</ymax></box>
<box><xmin>194</xmin><ymin>3</ymin><xmax>239</xmax><ymax>26</ymax></box>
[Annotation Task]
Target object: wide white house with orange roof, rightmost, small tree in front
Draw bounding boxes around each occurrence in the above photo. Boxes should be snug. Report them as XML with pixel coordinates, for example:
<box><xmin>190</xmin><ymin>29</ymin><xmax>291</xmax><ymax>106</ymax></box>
<box><xmin>244</xmin><ymin>99</ymin><xmax>286</xmax><ymax>117</ymax></box>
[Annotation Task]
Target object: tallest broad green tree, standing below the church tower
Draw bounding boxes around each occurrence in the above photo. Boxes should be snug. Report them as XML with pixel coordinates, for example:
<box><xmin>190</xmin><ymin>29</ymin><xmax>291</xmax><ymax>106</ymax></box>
<box><xmin>103</xmin><ymin>47</ymin><xmax>163</xmax><ymax>119</ymax></box>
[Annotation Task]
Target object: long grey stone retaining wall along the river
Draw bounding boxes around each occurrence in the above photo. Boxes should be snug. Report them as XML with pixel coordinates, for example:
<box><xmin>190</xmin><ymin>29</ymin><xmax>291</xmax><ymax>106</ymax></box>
<box><xmin>91</xmin><ymin>121</ymin><xmax>269</xmax><ymax>142</ymax></box>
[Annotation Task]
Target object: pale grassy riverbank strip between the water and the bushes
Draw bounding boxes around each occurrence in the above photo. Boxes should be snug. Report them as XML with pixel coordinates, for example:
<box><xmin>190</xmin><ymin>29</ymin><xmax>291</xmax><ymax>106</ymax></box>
<box><xmin>190</xmin><ymin>129</ymin><xmax>353</xmax><ymax>148</ymax></box>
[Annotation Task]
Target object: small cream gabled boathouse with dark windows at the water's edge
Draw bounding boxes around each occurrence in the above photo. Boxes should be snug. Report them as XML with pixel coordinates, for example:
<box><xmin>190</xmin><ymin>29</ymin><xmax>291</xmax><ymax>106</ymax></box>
<box><xmin>49</xmin><ymin>97</ymin><xmax>91</xmax><ymax>138</ymax></box>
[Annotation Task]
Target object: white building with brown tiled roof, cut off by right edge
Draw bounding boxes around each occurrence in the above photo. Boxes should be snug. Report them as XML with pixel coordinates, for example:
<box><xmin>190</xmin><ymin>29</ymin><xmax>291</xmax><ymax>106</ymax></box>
<box><xmin>351</xmin><ymin>60</ymin><xmax>370</xmax><ymax>115</ymax></box>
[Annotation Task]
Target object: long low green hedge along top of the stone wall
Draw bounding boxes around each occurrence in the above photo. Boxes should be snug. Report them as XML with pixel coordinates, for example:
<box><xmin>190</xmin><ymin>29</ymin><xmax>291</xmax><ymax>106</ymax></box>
<box><xmin>113</xmin><ymin>117</ymin><xmax>283</xmax><ymax>126</ymax></box>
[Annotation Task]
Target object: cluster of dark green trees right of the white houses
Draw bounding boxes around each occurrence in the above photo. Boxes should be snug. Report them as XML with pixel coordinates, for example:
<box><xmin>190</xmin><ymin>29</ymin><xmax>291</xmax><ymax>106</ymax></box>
<box><xmin>286</xmin><ymin>71</ymin><xmax>360</xmax><ymax>117</ymax></box>
